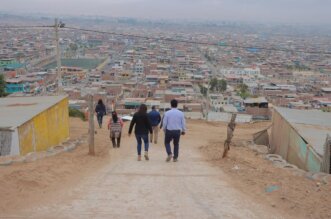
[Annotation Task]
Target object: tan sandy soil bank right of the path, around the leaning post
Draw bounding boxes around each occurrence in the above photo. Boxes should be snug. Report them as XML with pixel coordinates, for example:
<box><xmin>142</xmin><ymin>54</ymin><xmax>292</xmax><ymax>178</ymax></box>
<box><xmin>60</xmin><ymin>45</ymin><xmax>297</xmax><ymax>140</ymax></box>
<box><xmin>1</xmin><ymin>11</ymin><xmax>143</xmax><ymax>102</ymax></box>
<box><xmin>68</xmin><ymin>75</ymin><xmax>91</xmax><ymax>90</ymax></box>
<box><xmin>200</xmin><ymin>123</ymin><xmax>331</xmax><ymax>218</ymax></box>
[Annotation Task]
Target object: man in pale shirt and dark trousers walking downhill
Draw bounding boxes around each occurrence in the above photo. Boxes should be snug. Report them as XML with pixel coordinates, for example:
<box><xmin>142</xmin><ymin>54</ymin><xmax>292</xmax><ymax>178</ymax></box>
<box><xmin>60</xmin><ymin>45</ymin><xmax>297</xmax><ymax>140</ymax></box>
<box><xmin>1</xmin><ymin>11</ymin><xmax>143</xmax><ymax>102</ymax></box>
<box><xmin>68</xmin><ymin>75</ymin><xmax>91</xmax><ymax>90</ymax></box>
<box><xmin>162</xmin><ymin>99</ymin><xmax>186</xmax><ymax>162</ymax></box>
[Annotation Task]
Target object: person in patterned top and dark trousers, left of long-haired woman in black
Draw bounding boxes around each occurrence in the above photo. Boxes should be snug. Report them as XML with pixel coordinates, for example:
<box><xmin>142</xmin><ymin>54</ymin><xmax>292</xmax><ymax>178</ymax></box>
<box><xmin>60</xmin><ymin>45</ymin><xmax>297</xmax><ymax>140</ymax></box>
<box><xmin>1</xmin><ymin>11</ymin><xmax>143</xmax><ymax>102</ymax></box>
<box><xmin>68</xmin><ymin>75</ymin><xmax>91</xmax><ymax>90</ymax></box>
<box><xmin>108</xmin><ymin>111</ymin><xmax>123</xmax><ymax>148</ymax></box>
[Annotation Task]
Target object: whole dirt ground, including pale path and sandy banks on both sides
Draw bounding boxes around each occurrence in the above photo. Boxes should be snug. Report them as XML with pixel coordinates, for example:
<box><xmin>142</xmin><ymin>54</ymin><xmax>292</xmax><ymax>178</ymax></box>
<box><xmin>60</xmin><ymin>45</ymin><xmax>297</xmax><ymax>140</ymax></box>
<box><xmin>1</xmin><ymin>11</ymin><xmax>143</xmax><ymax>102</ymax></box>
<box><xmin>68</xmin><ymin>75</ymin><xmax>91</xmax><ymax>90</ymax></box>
<box><xmin>0</xmin><ymin>119</ymin><xmax>331</xmax><ymax>218</ymax></box>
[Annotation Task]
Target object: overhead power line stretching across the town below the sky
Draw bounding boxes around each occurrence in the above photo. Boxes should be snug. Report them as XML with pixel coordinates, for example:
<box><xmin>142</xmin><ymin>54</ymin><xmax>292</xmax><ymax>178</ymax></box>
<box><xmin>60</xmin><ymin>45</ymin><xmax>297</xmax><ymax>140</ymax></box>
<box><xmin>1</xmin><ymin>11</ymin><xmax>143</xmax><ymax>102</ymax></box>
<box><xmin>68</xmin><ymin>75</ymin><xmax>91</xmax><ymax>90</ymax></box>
<box><xmin>0</xmin><ymin>25</ymin><xmax>331</xmax><ymax>55</ymax></box>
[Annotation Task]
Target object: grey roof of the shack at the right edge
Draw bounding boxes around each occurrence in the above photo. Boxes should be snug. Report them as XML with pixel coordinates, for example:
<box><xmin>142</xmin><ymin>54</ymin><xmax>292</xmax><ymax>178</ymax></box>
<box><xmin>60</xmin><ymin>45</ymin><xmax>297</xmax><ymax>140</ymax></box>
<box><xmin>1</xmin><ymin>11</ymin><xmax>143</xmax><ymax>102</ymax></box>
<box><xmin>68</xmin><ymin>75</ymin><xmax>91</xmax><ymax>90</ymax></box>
<box><xmin>275</xmin><ymin>107</ymin><xmax>331</xmax><ymax>156</ymax></box>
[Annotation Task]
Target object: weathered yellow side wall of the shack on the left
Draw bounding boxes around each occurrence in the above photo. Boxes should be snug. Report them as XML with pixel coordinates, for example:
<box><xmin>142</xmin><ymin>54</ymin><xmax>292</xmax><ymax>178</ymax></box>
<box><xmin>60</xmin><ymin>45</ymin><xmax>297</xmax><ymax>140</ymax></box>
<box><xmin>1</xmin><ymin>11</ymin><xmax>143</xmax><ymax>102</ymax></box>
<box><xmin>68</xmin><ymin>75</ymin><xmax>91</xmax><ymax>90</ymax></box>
<box><xmin>18</xmin><ymin>98</ymin><xmax>69</xmax><ymax>155</ymax></box>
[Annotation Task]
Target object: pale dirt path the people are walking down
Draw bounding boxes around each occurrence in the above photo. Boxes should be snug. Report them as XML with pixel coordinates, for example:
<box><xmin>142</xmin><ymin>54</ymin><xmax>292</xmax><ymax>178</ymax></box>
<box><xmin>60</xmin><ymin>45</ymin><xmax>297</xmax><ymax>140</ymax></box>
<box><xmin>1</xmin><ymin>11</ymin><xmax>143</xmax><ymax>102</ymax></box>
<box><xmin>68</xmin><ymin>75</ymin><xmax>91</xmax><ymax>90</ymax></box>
<box><xmin>0</xmin><ymin>122</ymin><xmax>288</xmax><ymax>219</ymax></box>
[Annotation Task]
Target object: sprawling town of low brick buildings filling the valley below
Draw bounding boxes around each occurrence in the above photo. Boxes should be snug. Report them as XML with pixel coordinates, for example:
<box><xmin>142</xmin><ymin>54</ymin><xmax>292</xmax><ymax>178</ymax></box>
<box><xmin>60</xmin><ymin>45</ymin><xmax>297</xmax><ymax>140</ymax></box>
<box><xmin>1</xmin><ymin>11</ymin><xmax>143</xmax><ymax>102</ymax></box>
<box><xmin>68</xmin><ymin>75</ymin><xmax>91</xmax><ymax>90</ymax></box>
<box><xmin>0</xmin><ymin>15</ymin><xmax>331</xmax><ymax>122</ymax></box>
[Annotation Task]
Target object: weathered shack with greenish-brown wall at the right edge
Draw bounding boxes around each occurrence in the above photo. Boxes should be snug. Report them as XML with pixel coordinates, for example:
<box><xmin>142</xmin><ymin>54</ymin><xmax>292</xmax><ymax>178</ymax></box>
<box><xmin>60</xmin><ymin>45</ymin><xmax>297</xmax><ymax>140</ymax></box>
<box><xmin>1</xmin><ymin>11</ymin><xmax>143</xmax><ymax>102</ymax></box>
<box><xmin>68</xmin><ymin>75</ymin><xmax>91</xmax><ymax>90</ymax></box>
<box><xmin>270</xmin><ymin>107</ymin><xmax>331</xmax><ymax>173</ymax></box>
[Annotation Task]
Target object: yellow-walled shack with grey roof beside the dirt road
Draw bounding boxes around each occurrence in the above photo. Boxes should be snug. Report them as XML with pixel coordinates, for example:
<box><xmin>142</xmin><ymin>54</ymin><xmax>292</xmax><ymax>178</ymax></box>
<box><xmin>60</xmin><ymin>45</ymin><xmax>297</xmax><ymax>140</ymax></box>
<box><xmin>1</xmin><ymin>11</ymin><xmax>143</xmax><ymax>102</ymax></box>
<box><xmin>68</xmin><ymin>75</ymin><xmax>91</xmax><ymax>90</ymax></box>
<box><xmin>0</xmin><ymin>96</ymin><xmax>69</xmax><ymax>156</ymax></box>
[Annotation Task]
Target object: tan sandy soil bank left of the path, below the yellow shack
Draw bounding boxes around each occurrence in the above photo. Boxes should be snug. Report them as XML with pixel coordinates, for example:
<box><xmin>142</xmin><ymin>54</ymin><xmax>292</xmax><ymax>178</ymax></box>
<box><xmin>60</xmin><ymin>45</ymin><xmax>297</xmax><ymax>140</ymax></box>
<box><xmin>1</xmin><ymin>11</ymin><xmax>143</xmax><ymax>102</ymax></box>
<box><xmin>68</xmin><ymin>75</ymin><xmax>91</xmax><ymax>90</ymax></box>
<box><xmin>0</xmin><ymin>119</ymin><xmax>110</xmax><ymax>218</ymax></box>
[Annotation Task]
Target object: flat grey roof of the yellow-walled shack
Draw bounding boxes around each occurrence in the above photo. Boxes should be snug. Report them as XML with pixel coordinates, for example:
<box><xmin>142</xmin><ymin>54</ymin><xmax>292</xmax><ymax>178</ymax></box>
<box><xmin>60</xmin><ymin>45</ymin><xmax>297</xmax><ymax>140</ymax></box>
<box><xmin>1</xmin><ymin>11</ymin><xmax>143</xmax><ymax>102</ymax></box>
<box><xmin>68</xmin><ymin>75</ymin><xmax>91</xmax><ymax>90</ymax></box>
<box><xmin>0</xmin><ymin>96</ymin><xmax>67</xmax><ymax>129</ymax></box>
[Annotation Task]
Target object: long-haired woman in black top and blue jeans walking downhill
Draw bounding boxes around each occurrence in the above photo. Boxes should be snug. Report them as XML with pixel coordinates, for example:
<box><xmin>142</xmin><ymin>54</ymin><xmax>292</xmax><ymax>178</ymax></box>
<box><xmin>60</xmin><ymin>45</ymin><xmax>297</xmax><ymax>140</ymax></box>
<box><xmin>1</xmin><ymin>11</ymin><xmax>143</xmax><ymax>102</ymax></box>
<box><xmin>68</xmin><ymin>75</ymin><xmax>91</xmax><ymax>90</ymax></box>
<box><xmin>129</xmin><ymin>104</ymin><xmax>153</xmax><ymax>161</ymax></box>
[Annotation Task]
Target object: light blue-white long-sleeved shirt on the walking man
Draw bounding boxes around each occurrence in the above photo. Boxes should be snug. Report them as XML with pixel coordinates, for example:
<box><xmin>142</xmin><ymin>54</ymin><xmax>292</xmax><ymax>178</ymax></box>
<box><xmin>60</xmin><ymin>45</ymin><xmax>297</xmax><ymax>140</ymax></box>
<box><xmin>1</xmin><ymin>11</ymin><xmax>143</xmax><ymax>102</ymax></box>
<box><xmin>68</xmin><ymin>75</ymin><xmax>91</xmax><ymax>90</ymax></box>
<box><xmin>162</xmin><ymin>108</ymin><xmax>186</xmax><ymax>132</ymax></box>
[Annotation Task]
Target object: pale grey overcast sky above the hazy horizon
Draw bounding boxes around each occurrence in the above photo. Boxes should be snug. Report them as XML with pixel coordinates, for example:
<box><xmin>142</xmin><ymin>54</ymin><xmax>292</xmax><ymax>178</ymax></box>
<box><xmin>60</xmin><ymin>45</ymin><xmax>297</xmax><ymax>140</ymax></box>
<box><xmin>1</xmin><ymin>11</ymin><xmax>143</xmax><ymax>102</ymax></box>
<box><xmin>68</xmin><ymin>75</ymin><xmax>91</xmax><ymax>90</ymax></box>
<box><xmin>0</xmin><ymin>0</ymin><xmax>331</xmax><ymax>24</ymax></box>
